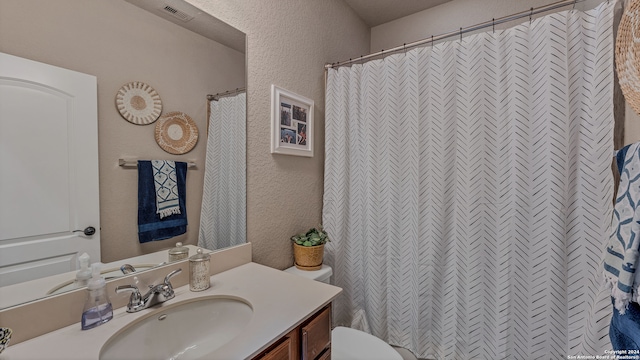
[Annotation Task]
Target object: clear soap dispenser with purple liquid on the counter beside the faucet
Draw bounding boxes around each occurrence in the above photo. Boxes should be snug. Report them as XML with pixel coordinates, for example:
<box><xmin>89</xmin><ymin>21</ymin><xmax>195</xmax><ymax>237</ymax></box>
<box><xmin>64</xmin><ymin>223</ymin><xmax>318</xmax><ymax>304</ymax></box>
<box><xmin>82</xmin><ymin>263</ymin><xmax>113</xmax><ymax>330</ymax></box>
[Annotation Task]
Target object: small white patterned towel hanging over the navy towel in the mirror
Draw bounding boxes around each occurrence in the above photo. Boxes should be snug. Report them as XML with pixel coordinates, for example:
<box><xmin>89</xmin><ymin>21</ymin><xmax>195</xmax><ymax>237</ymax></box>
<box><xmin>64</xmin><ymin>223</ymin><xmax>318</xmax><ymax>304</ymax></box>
<box><xmin>151</xmin><ymin>160</ymin><xmax>180</xmax><ymax>219</ymax></box>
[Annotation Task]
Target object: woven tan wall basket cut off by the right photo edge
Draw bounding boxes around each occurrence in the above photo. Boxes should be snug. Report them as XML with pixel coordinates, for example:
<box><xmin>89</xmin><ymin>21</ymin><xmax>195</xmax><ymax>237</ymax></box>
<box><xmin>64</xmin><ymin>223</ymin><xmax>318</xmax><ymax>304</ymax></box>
<box><xmin>616</xmin><ymin>0</ymin><xmax>640</xmax><ymax>114</ymax></box>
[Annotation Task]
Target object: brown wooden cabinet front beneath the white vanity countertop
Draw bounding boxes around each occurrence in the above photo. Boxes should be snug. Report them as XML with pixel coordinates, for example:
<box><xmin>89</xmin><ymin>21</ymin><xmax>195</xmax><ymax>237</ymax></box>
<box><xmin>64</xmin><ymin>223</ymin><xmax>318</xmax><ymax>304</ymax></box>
<box><xmin>253</xmin><ymin>304</ymin><xmax>331</xmax><ymax>360</ymax></box>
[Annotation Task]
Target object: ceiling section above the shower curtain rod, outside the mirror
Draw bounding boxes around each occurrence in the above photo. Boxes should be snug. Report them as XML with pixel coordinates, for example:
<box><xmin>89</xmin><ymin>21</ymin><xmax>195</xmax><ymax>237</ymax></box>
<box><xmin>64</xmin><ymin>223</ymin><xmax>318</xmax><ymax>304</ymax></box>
<box><xmin>345</xmin><ymin>0</ymin><xmax>451</xmax><ymax>27</ymax></box>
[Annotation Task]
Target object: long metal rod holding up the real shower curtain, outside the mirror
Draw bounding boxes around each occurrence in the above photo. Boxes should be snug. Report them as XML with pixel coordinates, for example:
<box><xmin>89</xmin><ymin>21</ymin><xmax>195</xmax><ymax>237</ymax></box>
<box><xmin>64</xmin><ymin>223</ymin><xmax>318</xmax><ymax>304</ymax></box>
<box><xmin>324</xmin><ymin>0</ymin><xmax>584</xmax><ymax>69</ymax></box>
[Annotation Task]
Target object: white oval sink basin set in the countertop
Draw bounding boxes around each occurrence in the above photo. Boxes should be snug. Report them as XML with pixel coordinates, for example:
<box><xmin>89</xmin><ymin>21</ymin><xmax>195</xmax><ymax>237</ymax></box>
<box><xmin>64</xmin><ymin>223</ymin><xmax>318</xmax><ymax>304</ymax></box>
<box><xmin>100</xmin><ymin>296</ymin><xmax>253</xmax><ymax>360</ymax></box>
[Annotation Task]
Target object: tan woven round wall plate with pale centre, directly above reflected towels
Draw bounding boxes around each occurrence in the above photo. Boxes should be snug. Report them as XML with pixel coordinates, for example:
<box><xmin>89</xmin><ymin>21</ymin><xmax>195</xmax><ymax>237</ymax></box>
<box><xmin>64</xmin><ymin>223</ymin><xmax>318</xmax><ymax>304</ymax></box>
<box><xmin>156</xmin><ymin>111</ymin><xmax>198</xmax><ymax>155</ymax></box>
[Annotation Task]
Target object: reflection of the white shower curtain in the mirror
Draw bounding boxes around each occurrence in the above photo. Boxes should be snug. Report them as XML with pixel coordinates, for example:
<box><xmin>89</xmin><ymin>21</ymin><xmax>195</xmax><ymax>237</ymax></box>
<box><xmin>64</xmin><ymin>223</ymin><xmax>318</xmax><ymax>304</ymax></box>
<box><xmin>198</xmin><ymin>93</ymin><xmax>246</xmax><ymax>250</ymax></box>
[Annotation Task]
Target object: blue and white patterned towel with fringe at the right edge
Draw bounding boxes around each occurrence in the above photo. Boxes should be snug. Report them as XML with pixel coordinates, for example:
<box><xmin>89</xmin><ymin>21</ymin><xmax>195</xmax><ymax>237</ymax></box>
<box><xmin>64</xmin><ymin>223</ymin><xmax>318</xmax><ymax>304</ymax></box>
<box><xmin>604</xmin><ymin>143</ymin><xmax>640</xmax><ymax>314</ymax></box>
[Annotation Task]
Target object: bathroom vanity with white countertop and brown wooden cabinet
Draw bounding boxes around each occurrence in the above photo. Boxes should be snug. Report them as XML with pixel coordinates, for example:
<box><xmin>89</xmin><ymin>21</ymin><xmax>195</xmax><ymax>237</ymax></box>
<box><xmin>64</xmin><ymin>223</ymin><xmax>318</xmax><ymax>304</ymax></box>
<box><xmin>1</xmin><ymin>262</ymin><xmax>342</xmax><ymax>360</ymax></box>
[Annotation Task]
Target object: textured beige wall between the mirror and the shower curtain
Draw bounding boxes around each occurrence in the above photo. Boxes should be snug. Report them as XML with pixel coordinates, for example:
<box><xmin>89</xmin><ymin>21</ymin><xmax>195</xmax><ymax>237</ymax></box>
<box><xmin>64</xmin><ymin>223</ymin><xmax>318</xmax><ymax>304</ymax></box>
<box><xmin>182</xmin><ymin>0</ymin><xmax>369</xmax><ymax>269</ymax></box>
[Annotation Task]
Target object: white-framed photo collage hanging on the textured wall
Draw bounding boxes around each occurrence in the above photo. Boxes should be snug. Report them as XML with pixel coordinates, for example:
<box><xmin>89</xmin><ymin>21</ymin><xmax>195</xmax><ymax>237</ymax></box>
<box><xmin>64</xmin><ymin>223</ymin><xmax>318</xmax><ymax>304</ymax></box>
<box><xmin>271</xmin><ymin>85</ymin><xmax>314</xmax><ymax>157</ymax></box>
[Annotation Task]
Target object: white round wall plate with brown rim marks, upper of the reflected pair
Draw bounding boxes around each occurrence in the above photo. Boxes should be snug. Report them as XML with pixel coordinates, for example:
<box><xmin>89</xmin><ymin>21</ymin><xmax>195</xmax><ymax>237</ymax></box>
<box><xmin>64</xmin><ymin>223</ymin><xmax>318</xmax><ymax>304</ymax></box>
<box><xmin>116</xmin><ymin>81</ymin><xmax>162</xmax><ymax>125</ymax></box>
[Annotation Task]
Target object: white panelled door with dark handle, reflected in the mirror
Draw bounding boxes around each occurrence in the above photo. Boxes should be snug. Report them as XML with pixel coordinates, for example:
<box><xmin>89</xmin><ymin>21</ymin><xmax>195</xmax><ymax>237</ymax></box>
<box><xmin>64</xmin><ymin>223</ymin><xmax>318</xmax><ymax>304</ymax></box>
<box><xmin>0</xmin><ymin>53</ymin><xmax>100</xmax><ymax>286</ymax></box>
